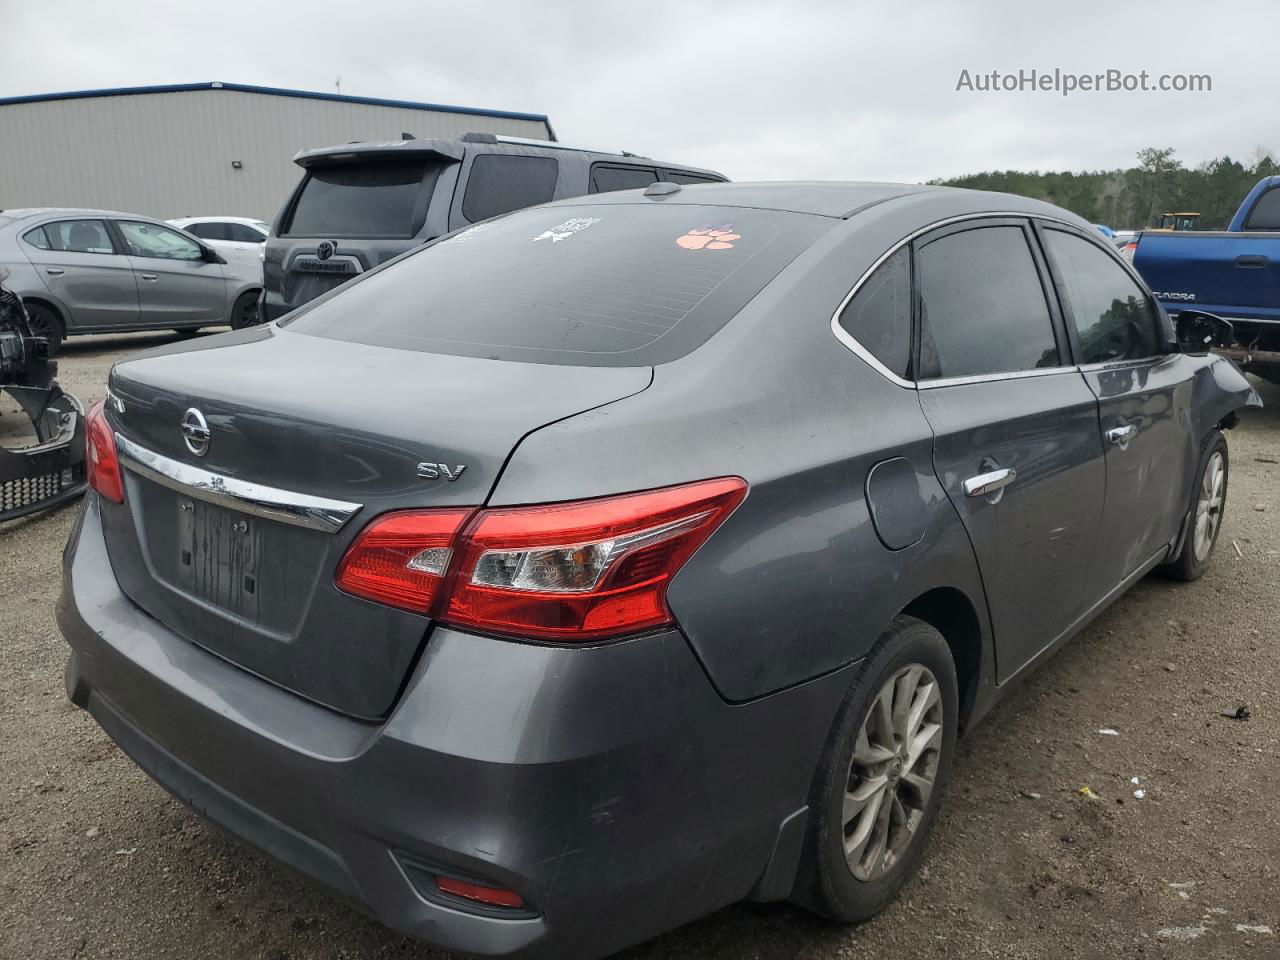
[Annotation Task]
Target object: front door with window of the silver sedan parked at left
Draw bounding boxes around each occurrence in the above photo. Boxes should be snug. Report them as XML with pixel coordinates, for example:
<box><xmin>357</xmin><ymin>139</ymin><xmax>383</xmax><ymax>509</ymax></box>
<box><xmin>113</xmin><ymin>220</ymin><xmax>229</xmax><ymax>326</ymax></box>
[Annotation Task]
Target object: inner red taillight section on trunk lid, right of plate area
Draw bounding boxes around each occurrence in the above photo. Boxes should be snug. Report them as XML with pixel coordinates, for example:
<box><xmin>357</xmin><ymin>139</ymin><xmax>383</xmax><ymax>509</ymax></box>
<box><xmin>337</xmin><ymin>508</ymin><xmax>471</xmax><ymax>613</ymax></box>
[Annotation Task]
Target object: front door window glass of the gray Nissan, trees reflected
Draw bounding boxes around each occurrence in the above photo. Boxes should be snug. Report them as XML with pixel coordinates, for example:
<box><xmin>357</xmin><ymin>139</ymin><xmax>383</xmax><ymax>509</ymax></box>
<box><xmin>1044</xmin><ymin>230</ymin><xmax>1161</xmax><ymax>364</ymax></box>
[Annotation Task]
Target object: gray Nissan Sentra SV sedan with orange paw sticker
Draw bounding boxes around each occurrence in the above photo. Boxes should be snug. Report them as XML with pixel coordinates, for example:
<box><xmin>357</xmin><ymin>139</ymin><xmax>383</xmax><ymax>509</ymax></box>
<box><xmin>58</xmin><ymin>183</ymin><xmax>1258</xmax><ymax>960</ymax></box>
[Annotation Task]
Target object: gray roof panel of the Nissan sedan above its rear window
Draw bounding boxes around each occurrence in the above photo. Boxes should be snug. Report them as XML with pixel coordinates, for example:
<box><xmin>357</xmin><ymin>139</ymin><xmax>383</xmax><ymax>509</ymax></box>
<box><xmin>557</xmin><ymin>180</ymin><xmax>1074</xmax><ymax>225</ymax></box>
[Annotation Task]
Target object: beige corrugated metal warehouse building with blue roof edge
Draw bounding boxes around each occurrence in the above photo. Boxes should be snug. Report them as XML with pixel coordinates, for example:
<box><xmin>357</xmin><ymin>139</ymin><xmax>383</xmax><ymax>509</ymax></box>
<box><xmin>0</xmin><ymin>82</ymin><xmax>556</xmax><ymax>220</ymax></box>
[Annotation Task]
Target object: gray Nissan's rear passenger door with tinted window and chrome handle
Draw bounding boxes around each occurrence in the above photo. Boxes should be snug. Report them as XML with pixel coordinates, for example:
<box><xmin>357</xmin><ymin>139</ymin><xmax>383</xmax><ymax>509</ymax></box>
<box><xmin>914</xmin><ymin>219</ymin><xmax>1106</xmax><ymax>681</ymax></box>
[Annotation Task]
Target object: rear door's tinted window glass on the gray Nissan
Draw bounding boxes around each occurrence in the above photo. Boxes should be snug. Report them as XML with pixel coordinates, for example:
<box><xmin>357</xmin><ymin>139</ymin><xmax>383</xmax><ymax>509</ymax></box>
<box><xmin>916</xmin><ymin>227</ymin><xmax>1061</xmax><ymax>379</ymax></box>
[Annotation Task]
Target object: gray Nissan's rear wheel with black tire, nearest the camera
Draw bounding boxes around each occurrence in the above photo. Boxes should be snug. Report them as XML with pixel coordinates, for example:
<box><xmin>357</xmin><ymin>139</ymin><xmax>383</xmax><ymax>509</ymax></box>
<box><xmin>794</xmin><ymin>617</ymin><xmax>959</xmax><ymax>923</ymax></box>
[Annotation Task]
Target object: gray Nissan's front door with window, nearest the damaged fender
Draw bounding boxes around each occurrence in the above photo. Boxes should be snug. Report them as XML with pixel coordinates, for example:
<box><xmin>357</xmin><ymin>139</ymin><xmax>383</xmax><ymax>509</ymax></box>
<box><xmin>1041</xmin><ymin>225</ymin><xmax>1199</xmax><ymax>598</ymax></box>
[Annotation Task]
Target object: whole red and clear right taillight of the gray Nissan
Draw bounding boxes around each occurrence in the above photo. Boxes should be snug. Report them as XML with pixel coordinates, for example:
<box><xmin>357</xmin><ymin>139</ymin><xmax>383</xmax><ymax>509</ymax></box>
<box><xmin>338</xmin><ymin>477</ymin><xmax>746</xmax><ymax>643</ymax></box>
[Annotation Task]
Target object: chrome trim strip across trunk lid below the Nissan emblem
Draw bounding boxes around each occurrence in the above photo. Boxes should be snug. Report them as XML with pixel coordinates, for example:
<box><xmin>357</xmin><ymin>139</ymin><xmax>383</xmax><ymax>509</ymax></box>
<box><xmin>115</xmin><ymin>434</ymin><xmax>364</xmax><ymax>534</ymax></box>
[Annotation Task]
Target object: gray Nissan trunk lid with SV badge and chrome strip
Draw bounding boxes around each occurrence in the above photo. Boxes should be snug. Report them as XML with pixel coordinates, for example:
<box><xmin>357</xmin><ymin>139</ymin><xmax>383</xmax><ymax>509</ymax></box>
<box><xmin>104</xmin><ymin>328</ymin><xmax>652</xmax><ymax>718</ymax></box>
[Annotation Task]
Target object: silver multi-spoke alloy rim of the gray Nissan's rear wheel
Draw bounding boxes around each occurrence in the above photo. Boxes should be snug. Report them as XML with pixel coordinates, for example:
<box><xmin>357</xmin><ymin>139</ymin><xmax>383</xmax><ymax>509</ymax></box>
<box><xmin>841</xmin><ymin>663</ymin><xmax>946</xmax><ymax>881</ymax></box>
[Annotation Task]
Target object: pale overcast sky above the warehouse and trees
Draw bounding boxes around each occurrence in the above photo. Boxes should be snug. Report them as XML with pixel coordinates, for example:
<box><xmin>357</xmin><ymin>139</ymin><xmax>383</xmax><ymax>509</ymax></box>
<box><xmin>0</xmin><ymin>0</ymin><xmax>1280</xmax><ymax>182</ymax></box>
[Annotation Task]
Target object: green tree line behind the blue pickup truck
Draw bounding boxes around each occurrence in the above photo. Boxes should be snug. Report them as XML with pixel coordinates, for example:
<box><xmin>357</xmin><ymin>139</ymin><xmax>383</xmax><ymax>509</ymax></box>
<box><xmin>932</xmin><ymin>147</ymin><xmax>1280</xmax><ymax>230</ymax></box>
